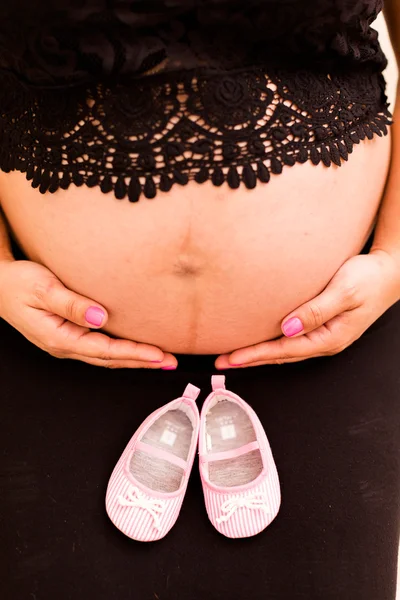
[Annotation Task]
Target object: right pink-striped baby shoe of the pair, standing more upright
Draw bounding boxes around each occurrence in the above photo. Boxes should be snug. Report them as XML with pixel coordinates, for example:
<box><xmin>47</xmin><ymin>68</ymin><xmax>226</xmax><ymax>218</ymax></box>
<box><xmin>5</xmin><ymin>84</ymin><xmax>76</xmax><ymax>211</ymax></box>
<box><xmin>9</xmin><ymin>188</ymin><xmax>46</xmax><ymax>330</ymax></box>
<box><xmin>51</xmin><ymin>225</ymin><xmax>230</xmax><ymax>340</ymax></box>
<box><xmin>199</xmin><ymin>375</ymin><xmax>281</xmax><ymax>538</ymax></box>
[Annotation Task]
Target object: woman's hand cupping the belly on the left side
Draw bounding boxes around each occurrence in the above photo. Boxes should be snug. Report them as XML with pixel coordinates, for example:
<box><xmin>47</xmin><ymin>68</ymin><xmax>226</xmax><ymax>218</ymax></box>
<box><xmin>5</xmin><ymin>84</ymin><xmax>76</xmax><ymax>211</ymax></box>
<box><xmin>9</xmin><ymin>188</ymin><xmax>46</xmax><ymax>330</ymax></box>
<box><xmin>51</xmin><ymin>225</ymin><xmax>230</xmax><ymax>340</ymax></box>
<box><xmin>0</xmin><ymin>260</ymin><xmax>177</xmax><ymax>369</ymax></box>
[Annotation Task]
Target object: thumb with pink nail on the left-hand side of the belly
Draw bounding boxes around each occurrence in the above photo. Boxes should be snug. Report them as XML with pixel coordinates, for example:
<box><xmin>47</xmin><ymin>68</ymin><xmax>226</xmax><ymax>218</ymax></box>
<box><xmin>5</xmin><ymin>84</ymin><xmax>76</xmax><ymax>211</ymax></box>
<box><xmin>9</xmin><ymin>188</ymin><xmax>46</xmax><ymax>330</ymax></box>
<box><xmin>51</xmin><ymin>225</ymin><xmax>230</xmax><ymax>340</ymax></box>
<box><xmin>45</xmin><ymin>280</ymin><xmax>108</xmax><ymax>329</ymax></box>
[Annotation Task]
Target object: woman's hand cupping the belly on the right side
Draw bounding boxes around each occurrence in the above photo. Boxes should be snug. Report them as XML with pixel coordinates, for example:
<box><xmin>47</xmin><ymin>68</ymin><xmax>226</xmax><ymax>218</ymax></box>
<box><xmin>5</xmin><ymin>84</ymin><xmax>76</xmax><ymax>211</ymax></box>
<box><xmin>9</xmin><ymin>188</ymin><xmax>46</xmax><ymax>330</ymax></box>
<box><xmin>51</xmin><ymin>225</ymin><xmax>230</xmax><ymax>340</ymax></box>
<box><xmin>215</xmin><ymin>249</ymin><xmax>400</xmax><ymax>369</ymax></box>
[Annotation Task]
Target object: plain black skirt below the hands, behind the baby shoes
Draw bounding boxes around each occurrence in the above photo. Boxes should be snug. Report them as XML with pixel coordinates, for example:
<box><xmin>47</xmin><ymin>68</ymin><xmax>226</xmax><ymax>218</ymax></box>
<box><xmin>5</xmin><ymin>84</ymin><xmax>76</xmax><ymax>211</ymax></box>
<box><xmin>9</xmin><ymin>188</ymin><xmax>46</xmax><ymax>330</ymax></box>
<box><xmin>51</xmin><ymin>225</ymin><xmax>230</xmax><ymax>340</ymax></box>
<box><xmin>0</xmin><ymin>236</ymin><xmax>400</xmax><ymax>600</ymax></box>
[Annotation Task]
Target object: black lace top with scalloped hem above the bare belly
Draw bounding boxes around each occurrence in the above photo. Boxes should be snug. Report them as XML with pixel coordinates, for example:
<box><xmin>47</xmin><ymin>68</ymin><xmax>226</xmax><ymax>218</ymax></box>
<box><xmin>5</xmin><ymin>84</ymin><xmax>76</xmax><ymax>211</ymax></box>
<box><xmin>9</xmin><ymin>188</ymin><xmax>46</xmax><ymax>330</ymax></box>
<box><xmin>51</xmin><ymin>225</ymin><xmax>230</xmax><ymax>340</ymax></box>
<box><xmin>0</xmin><ymin>0</ymin><xmax>391</xmax><ymax>202</ymax></box>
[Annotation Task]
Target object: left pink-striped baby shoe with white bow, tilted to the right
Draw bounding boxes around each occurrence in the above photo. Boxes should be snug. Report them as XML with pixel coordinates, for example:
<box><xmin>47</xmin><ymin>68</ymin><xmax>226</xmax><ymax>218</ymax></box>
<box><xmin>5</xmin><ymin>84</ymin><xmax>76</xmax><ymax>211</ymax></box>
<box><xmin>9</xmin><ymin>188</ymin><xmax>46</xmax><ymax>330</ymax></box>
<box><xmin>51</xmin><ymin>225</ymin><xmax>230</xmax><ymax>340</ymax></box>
<box><xmin>106</xmin><ymin>383</ymin><xmax>200</xmax><ymax>542</ymax></box>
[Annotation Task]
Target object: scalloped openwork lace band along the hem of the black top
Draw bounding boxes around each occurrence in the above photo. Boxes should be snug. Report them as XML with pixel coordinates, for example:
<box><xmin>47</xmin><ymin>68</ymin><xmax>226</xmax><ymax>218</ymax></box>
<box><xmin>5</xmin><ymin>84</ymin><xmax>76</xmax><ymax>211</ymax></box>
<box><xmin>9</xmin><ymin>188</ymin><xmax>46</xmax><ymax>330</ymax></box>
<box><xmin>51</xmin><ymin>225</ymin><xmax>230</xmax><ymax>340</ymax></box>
<box><xmin>0</xmin><ymin>67</ymin><xmax>392</xmax><ymax>202</ymax></box>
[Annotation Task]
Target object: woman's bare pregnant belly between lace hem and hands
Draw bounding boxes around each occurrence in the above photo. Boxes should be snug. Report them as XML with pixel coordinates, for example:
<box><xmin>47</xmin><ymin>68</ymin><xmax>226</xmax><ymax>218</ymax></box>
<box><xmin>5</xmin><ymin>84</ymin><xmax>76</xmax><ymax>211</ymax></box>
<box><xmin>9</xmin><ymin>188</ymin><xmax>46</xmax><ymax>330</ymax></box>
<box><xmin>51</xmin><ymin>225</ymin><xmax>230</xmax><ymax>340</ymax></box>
<box><xmin>0</xmin><ymin>136</ymin><xmax>390</xmax><ymax>354</ymax></box>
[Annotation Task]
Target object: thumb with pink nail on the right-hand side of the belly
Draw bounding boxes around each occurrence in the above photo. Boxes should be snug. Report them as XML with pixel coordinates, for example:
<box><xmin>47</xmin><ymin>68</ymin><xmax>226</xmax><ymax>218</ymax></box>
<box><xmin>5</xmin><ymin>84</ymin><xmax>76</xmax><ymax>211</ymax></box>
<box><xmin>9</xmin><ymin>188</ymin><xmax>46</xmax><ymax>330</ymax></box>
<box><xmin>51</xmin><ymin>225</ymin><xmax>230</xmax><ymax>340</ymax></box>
<box><xmin>281</xmin><ymin>285</ymin><xmax>350</xmax><ymax>337</ymax></box>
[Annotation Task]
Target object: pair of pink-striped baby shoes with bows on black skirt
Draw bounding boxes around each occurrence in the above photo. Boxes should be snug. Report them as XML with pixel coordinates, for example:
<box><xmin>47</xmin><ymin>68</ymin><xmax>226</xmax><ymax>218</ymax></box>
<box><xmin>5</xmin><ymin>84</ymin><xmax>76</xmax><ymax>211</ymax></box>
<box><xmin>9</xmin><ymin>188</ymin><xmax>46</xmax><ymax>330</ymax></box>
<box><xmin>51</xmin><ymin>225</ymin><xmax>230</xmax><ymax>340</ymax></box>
<box><xmin>106</xmin><ymin>375</ymin><xmax>281</xmax><ymax>542</ymax></box>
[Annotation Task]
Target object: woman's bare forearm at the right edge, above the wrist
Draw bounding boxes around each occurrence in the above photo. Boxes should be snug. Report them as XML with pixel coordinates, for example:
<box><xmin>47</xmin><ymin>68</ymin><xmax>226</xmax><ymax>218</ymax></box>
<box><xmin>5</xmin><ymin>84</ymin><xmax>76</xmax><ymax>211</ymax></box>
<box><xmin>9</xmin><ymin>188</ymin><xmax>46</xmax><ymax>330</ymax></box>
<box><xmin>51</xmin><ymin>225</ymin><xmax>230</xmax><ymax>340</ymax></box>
<box><xmin>371</xmin><ymin>84</ymin><xmax>400</xmax><ymax>268</ymax></box>
